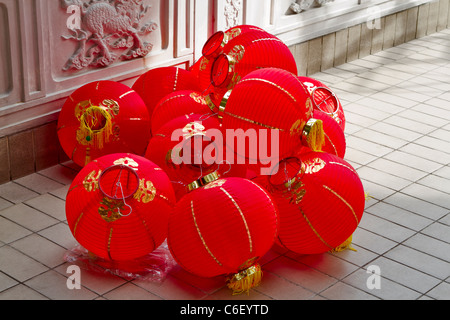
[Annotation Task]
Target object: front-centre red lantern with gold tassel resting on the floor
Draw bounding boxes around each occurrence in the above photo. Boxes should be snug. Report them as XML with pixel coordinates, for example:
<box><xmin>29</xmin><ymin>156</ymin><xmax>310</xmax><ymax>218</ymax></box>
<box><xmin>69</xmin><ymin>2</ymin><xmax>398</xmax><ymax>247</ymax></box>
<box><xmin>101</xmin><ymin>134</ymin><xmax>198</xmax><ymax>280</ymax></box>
<box><xmin>167</xmin><ymin>173</ymin><xmax>278</xmax><ymax>293</ymax></box>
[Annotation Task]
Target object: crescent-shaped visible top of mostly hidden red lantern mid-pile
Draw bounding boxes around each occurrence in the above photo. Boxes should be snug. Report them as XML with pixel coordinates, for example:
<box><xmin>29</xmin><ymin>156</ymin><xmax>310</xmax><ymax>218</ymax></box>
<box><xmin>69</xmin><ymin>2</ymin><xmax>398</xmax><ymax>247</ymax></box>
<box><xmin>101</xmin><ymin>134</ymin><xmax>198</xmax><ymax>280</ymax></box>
<box><xmin>152</xmin><ymin>90</ymin><xmax>211</xmax><ymax>132</ymax></box>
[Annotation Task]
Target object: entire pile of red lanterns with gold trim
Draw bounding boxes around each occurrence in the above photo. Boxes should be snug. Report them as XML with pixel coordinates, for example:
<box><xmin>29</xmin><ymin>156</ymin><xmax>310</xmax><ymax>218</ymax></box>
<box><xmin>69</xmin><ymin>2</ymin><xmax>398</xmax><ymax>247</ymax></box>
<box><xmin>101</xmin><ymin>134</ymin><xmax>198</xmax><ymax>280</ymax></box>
<box><xmin>58</xmin><ymin>25</ymin><xmax>365</xmax><ymax>293</ymax></box>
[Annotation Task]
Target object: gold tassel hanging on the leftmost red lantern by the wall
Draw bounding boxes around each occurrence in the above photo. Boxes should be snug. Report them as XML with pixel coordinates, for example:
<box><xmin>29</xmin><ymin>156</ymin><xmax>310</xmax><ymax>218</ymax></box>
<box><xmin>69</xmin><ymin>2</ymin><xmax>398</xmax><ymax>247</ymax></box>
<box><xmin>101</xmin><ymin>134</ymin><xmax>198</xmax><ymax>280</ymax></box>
<box><xmin>78</xmin><ymin>106</ymin><xmax>113</xmax><ymax>149</ymax></box>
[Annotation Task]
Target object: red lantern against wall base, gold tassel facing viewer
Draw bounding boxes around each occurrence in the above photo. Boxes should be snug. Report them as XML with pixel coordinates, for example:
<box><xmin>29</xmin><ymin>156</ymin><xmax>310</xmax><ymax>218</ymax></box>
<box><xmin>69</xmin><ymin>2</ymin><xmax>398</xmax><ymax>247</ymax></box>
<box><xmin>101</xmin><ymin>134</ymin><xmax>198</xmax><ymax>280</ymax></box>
<box><xmin>58</xmin><ymin>81</ymin><xmax>150</xmax><ymax>167</ymax></box>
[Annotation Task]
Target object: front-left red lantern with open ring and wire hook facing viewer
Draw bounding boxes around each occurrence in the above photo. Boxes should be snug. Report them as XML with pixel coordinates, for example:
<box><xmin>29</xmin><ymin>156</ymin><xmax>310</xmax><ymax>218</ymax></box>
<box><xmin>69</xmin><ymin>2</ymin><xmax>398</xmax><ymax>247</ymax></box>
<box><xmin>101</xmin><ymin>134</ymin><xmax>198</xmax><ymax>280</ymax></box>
<box><xmin>66</xmin><ymin>153</ymin><xmax>175</xmax><ymax>261</ymax></box>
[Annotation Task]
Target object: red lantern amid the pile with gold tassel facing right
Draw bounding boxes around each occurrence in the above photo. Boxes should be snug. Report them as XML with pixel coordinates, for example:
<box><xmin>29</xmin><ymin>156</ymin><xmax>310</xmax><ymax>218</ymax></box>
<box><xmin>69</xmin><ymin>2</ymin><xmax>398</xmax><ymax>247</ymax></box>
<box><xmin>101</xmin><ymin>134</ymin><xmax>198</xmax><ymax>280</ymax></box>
<box><xmin>216</xmin><ymin>68</ymin><xmax>324</xmax><ymax>169</ymax></box>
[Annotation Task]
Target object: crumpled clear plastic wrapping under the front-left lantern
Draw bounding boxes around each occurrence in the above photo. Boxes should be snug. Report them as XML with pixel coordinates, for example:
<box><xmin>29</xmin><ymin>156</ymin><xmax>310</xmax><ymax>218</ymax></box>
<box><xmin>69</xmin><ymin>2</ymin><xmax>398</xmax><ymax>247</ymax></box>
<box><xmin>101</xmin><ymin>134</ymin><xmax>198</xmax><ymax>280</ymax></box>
<box><xmin>64</xmin><ymin>241</ymin><xmax>176</xmax><ymax>282</ymax></box>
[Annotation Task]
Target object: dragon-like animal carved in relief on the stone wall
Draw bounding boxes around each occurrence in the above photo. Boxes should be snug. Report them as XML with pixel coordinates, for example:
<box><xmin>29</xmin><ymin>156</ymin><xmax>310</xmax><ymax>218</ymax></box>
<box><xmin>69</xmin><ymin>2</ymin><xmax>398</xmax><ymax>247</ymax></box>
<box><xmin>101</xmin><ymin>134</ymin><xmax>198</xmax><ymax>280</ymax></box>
<box><xmin>61</xmin><ymin>0</ymin><xmax>158</xmax><ymax>70</ymax></box>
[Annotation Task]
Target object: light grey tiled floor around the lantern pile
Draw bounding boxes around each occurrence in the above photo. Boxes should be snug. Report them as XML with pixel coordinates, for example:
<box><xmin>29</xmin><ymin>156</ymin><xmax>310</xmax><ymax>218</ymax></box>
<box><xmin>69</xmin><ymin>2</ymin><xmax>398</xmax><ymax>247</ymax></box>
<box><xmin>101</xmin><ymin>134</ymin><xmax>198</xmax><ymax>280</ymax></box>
<box><xmin>0</xmin><ymin>30</ymin><xmax>450</xmax><ymax>300</ymax></box>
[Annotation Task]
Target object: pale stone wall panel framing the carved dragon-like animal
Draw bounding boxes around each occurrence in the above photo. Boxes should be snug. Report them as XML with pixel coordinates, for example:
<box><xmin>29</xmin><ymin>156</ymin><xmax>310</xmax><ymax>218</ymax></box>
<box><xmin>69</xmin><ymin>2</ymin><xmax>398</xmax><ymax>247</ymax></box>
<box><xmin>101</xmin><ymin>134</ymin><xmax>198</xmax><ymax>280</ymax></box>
<box><xmin>43</xmin><ymin>0</ymin><xmax>186</xmax><ymax>91</ymax></box>
